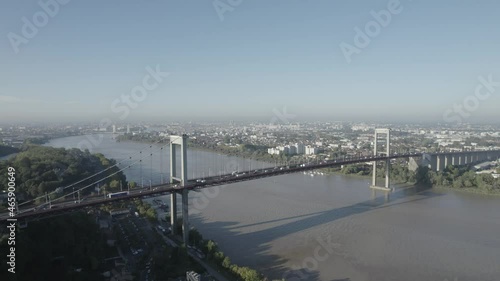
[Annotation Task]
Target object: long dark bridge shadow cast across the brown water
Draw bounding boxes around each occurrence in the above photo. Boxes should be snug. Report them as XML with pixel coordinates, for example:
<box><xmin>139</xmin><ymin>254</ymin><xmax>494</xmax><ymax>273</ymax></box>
<box><xmin>191</xmin><ymin>184</ymin><xmax>443</xmax><ymax>281</ymax></box>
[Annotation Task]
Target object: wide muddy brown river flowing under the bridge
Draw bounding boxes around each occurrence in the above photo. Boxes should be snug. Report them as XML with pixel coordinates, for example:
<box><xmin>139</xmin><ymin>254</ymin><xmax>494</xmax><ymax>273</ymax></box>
<box><xmin>46</xmin><ymin>135</ymin><xmax>500</xmax><ymax>281</ymax></box>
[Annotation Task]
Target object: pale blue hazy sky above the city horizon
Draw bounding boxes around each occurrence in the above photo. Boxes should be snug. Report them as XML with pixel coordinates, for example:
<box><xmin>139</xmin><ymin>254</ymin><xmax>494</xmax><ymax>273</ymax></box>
<box><xmin>0</xmin><ymin>0</ymin><xmax>500</xmax><ymax>121</ymax></box>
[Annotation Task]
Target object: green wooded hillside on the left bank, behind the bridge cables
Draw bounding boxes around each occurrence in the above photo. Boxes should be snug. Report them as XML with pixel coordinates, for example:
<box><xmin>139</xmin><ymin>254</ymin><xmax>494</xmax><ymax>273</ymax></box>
<box><xmin>0</xmin><ymin>145</ymin><xmax>127</xmax><ymax>205</ymax></box>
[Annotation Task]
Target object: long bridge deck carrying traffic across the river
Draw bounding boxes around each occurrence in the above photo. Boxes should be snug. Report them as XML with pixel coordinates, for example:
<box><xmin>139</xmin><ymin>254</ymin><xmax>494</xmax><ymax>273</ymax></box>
<box><xmin>0</xmin><ymin>153</ymin><xmax>492</xmax><ymax>222</ymax></box>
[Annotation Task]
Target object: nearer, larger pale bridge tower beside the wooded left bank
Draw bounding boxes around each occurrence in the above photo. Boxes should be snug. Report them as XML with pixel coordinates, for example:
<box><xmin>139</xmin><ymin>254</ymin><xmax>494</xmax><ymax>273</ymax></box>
<box><xmin>170</xmin><ymin>134</ymin><xmax>189</xmax><ymax>244</ymax></box>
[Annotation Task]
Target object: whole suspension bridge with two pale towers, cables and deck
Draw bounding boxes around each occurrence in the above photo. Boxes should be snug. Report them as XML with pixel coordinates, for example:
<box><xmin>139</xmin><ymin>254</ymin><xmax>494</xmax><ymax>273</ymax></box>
<box><xmin>0</xmin><ymin>129</ymin><xmax>500</xmax><ymax>241</ymax></box>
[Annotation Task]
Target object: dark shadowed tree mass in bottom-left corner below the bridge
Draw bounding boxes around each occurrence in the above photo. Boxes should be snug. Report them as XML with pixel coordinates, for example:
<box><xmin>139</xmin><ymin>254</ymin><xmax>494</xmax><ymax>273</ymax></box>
<box><xmin>0</xmin><ymin>213</ymin><xmax>108</xmax><ymax>281</ymax></box>
